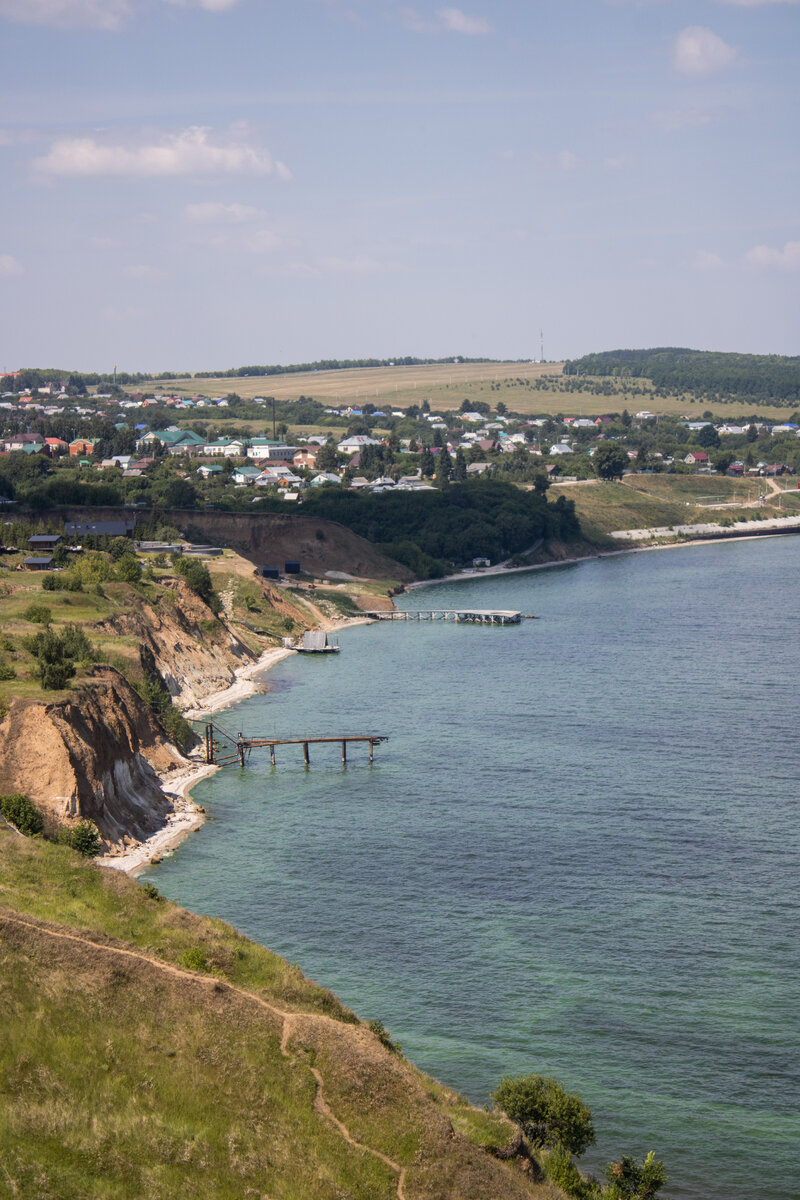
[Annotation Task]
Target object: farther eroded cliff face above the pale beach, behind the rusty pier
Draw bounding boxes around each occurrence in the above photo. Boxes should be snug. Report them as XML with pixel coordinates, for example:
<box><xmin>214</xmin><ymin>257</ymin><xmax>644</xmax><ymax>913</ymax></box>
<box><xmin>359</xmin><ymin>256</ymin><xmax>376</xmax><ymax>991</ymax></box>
<box><xmin>104</xmin><ymin>580</ymin><xmax>255</xmax><ymax>708</ymax></box>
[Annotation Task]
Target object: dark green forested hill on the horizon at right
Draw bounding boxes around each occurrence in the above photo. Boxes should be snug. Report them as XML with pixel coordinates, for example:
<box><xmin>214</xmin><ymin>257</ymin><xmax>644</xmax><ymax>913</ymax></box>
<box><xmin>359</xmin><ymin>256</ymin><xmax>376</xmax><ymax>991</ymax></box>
<box><xmin>564</xmin><ymin>347</ymin><xmax>800</xmax><ymax>404</ymax></box>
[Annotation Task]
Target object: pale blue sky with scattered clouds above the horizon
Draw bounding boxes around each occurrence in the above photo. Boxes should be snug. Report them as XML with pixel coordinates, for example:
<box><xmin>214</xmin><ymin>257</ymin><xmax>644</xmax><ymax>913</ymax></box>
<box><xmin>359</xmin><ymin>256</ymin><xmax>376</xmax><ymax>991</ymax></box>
<box><xmin>0</xmin><ymin>0</ymin><xmax>800</xmax><ymax>372</ymax></box>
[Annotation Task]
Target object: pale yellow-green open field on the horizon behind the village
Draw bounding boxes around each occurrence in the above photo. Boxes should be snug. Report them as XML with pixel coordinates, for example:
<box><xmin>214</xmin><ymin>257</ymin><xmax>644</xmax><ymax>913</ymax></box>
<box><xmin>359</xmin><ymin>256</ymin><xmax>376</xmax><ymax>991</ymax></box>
<box><xmin>143</xmin><ymin>362</ymin><xmax>793</xmax><ymax>420</ymax></box>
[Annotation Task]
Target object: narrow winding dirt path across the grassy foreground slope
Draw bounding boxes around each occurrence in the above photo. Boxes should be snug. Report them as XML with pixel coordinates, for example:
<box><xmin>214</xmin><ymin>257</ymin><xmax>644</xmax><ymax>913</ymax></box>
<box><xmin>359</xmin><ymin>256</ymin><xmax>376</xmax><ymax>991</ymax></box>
<box><xmin>0</xmin><ymin>911</ymin><xmax>408</xmax><ymax>1200</ymax></box>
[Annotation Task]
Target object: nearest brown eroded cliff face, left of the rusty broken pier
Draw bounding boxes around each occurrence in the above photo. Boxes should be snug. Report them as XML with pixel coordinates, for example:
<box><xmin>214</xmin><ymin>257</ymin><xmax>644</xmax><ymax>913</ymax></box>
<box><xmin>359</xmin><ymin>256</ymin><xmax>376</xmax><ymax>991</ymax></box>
<box><xmin>0</xmin><ymin>667</ymin><xmax>185</xmax><ymax>847</ymax></box>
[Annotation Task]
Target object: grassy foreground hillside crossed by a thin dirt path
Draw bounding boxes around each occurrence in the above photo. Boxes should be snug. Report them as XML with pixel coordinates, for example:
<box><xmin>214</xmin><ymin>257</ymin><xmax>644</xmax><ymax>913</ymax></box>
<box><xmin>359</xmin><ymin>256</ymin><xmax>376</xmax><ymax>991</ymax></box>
<box><xmin>0</xmin><ymin>828</ymin><xmax>563</xmax><ymax>1200</ymax></box>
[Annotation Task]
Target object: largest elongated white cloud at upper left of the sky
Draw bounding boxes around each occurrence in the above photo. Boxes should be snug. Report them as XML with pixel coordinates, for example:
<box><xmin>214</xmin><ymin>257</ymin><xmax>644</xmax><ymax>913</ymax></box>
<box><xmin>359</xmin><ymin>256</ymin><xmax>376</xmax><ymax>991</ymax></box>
<box><xmin>34</xmin><ymin>125</ymin><xmax>291</xmax><ymax>179</ymax></box>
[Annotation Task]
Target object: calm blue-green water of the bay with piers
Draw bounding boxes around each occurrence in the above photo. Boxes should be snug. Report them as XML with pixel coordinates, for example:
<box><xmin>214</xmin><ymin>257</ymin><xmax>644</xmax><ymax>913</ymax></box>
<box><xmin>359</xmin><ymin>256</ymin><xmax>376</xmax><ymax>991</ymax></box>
<box><xmin>151</xmin><ymin>538</ymin><xmax>800</xmax><ymax>1200</ymax></box>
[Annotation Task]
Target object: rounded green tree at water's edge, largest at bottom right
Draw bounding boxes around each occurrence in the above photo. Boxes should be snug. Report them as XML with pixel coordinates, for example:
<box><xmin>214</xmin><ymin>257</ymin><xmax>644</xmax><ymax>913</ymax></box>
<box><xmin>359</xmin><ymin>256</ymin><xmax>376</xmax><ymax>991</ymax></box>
<box><xmin>492</xmin><ymin>1075</ymin><xmax>595</xmax><ymax>1156</ymax></box>
